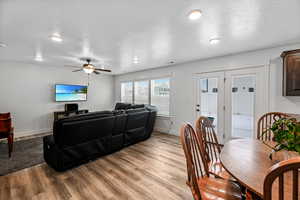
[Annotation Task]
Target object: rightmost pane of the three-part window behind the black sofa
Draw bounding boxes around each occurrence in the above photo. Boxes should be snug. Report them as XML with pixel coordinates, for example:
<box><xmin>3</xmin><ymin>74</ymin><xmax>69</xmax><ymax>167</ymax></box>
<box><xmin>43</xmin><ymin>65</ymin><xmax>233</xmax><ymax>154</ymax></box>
<box><xmin>151</xmin><ymin>78</ymin><xmax>170</xmax><ymax>116</ymax></box>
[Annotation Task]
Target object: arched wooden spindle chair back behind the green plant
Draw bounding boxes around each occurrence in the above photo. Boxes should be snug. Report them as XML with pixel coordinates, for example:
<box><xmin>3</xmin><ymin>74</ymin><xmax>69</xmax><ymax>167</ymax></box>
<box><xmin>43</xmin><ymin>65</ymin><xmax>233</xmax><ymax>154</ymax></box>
<box><xmin>256</xmin><ymin>112</ymin><xmax>289</xmax><ymax>141</ymax></box>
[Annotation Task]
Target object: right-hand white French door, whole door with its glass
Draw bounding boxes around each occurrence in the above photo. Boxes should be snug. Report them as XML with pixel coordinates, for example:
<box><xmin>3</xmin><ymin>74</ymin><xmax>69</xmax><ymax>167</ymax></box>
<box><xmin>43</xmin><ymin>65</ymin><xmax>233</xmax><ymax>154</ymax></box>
<box><xmin>225</xmin><ymin>67</ymin><xmax>267</xmax><ymax>141</ymax></box>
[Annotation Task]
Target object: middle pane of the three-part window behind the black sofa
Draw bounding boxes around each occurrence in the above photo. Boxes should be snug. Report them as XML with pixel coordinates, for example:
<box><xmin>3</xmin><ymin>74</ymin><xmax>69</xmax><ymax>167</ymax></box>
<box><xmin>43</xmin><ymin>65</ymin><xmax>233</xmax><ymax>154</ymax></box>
<box><xmin>134</xmin><ymin>81</ymin><xmax>149</xmax><ymax>104</ymax></box>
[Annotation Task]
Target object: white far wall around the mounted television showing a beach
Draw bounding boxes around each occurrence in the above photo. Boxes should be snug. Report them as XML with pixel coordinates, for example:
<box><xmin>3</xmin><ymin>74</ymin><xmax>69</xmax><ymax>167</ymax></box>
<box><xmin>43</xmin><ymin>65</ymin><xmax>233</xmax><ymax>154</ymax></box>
<box><xmin>0</xmin><ymin>62</ymin><xmax>115</xmax><ymax>137</ymax></box>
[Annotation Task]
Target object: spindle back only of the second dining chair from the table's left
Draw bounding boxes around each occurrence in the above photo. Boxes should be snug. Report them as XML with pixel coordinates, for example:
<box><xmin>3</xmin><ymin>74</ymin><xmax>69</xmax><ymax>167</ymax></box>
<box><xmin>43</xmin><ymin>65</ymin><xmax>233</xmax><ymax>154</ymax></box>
<box><xmin>196</xmin><ymin>116</ymin><xmax>221</xmax><ymax>165</ymax></box>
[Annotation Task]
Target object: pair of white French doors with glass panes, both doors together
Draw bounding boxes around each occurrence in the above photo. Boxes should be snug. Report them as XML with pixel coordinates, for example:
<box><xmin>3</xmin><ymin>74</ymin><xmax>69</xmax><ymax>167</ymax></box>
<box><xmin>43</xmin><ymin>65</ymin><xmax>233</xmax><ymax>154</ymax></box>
<box><xmin>196</xmin><ymin>67</ymin><xmax>267</xmax><ymax>143</ymax></box>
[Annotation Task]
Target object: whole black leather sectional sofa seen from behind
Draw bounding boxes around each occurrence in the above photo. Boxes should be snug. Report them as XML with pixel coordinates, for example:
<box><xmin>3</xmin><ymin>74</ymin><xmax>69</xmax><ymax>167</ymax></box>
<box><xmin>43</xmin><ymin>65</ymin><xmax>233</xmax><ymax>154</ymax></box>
<box><xmin>43</xmin><ymin>103</ymin><xmax>157</xmax><ymax>171</ymax></box>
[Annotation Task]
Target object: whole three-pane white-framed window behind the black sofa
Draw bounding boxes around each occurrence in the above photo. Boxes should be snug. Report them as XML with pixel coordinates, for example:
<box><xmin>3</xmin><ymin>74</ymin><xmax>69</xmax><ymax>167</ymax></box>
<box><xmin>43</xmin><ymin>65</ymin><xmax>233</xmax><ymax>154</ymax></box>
<box><xmin>121</xmin><ymin>78</ymin><xmax>170</xmax><ymax>116</ymax></box>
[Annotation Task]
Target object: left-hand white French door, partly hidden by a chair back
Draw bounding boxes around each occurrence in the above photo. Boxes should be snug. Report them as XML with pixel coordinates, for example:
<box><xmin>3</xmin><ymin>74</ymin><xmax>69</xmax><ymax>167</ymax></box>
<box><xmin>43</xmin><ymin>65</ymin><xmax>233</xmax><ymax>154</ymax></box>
<box><xmin>195</xmin><ymin>72</ymin><xmax>225</xmax><ymax>143</ymax></box>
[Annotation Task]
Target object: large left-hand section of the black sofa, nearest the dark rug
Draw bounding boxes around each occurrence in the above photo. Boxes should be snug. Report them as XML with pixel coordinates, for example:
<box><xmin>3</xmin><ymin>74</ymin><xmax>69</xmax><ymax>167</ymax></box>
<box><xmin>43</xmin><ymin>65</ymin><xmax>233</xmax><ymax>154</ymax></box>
<box><xmin>44</xmin><ymin>111</ymin><xmax>115</xmax><ymax>171</ymax></box>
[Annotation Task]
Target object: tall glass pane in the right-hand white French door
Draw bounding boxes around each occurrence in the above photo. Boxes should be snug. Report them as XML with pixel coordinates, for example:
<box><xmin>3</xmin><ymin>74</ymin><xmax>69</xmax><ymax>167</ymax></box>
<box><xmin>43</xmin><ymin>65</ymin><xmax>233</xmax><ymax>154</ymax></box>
<box><xmin>231</xmin><ymin>75</ymin><xmax>255</xmax><ymax>138</ymax></box>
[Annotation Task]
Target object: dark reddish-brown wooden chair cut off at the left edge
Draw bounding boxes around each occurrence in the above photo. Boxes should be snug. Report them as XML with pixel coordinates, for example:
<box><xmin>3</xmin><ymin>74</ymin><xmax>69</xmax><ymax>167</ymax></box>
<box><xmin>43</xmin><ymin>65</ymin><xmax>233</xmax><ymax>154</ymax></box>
<box><xmin>0</xmin><ymin>113</ymin><xmax>14</xmax><ymax>157</ymax></box>
